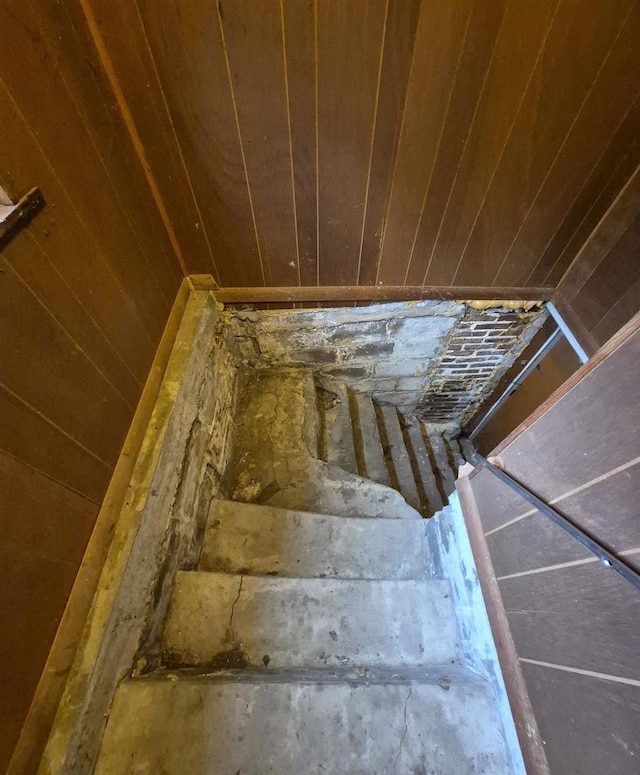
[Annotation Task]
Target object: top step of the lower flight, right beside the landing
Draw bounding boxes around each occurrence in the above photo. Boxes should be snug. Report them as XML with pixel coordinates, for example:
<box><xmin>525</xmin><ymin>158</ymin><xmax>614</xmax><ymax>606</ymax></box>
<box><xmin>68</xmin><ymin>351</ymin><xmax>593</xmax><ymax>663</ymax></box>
<box><xmin>316</xmin><ymin>377</ymin><xmax>358</xmax><ymax>474</ymax></box>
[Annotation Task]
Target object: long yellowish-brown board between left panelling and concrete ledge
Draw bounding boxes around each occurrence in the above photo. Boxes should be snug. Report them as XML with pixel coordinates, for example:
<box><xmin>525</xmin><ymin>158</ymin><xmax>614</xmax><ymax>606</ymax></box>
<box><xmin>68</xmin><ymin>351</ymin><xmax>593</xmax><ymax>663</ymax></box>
<box><xmin>7</xmin><ymin>278</ymin><xmax>192</xmax><ymax>775</ymax></box>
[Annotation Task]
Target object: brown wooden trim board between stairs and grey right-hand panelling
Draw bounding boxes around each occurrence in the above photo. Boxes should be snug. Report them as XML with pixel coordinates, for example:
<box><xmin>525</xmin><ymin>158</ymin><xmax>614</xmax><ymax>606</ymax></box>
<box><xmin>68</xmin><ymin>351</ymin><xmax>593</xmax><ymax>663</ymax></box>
<box><xmin>456</xmin><ymin>476</ymin><xmax>550</xmax><ymax>775</ymax></box>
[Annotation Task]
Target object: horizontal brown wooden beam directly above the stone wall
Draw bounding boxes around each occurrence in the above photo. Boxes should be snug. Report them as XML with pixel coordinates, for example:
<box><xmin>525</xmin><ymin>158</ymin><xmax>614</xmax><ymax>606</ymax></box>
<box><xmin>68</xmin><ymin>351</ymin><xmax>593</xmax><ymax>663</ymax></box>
<box><xmin>210</xmin><ymin>285</ymin><xmax>555</xmax><ymax>304</ymax></box>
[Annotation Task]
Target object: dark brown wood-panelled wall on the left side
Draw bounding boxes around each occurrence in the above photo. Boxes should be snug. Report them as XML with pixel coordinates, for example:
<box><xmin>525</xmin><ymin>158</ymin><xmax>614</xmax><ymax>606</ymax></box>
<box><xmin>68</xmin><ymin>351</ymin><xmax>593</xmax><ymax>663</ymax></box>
<box><xmin>0</xmin><ymin>0</ymin><xmax>182</xmax><ymax>772</ymax></box>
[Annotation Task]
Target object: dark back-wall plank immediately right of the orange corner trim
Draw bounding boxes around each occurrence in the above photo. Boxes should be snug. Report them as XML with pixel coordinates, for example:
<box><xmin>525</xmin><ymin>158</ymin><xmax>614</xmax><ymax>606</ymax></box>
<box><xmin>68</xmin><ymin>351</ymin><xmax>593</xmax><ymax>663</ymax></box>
<box><xmin>79</xmin><ymin>0</ymin><xmax>216</xmax><ymax>274</ymax></box>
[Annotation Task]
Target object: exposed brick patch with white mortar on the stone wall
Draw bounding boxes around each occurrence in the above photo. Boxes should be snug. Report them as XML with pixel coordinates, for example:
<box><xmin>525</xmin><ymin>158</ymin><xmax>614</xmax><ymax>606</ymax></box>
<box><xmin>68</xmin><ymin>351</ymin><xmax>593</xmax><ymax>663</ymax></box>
<box><xmin>417</xmin><ymin>308</ymin><xmax>546</xmax><ymax>425</ymax></box>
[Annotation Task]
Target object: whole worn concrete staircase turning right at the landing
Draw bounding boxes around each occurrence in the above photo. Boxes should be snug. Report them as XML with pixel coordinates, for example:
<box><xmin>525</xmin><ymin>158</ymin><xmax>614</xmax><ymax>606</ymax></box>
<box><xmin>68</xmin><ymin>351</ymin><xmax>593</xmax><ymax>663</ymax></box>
<box><xmin>95</xmin><ymin>370</ymin><xmax>513</xmax><ymax>775</ymax></box>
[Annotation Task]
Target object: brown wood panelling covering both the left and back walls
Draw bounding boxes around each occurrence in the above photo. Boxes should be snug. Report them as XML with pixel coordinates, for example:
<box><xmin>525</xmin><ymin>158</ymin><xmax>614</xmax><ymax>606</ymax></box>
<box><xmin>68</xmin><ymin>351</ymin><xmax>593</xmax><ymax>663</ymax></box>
<box><xmin>0</xmin><ymin>0</ymin><xmax>640</xmax><ymax>768</ymax></box>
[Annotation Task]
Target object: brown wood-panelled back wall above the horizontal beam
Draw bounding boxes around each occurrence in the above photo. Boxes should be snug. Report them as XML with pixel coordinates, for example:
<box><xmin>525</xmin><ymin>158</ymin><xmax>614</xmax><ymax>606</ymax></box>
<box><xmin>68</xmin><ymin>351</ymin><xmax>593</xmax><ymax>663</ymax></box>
<box><xmin>64</xmin><ymin>0</ymin><xmax>640</xmax><ymax>295</ymax></box>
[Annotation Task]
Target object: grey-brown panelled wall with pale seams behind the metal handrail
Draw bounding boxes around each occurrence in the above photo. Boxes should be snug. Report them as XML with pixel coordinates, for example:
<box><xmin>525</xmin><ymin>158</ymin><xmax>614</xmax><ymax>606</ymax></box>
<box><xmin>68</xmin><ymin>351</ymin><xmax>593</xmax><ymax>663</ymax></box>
<box><xmin>470</xmin><ymin>314</ymin><xmax>640</xmax><ymax>775</ymax></box>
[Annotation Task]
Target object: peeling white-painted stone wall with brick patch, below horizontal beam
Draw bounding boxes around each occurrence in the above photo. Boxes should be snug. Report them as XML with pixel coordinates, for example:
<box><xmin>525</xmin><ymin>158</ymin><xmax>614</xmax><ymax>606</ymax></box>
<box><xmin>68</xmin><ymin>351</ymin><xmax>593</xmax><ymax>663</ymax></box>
<box><xmin>227</xmin><ymin>301</ymin><xmax>546</xmax><ymax>423</ymax></box>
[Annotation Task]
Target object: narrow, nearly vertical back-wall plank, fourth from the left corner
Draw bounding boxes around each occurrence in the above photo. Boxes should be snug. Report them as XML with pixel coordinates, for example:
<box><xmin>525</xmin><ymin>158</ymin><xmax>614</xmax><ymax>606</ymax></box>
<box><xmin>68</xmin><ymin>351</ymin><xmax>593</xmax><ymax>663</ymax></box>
<box><xmin>281</xmin><ymin>0</ymin><xmax>318</xmax><ymax>285</ymax></box>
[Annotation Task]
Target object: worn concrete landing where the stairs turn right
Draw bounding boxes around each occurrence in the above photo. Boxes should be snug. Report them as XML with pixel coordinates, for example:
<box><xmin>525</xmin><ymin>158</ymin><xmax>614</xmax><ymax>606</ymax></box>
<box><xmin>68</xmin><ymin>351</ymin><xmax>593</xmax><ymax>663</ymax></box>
<box><xmin>228</xmin><ymin>369</ymin><xmax>420</xmax><ymax>519</ymax></box>
